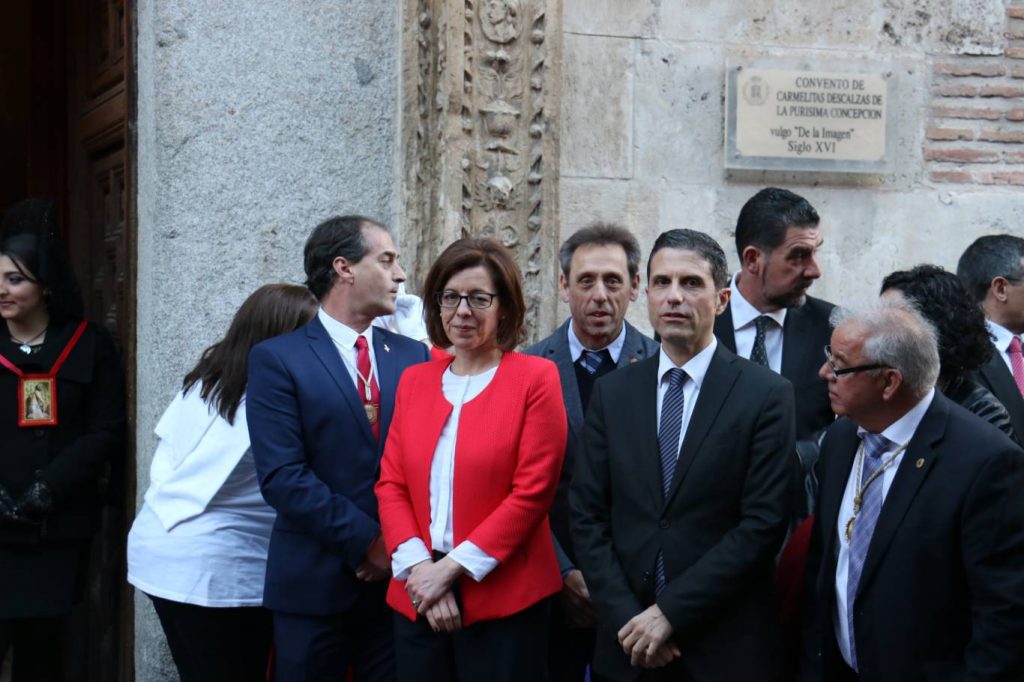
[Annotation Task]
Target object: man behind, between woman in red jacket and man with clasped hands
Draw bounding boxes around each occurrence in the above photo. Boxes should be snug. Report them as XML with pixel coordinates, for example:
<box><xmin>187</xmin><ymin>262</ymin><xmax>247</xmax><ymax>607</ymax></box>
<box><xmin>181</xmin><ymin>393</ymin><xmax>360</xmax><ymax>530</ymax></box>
<box><xmin>526</xmin><ymin>222</ymin><xmax>657</xmax><ymax>682</ymax></box>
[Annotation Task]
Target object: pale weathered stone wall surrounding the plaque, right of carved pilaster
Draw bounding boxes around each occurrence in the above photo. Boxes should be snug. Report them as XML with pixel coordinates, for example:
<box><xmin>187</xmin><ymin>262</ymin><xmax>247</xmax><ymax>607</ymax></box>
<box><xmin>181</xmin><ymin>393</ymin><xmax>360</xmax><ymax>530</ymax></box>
<box><xmin>550</xmin><ymin>0</ymin><xmax>1024</xmax><ymax>329</ymax></box>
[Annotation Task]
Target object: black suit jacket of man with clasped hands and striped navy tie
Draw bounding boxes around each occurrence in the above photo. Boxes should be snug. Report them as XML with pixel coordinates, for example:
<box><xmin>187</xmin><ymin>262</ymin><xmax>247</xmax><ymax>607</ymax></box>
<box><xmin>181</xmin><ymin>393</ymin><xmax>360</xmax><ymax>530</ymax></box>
<box><xmin>569</xmin><ymin>344</ymin><xmax>794</xmax><ymax>682</ymax></box>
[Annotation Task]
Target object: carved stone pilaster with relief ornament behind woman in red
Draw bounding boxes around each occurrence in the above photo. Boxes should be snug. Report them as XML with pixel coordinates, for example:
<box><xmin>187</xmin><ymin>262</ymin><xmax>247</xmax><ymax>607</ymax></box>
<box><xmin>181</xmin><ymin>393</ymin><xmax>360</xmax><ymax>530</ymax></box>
<box><xmin>401</xmin><ymin>0</ymin><xmax>562</xmax><ymax>341</ymax></box>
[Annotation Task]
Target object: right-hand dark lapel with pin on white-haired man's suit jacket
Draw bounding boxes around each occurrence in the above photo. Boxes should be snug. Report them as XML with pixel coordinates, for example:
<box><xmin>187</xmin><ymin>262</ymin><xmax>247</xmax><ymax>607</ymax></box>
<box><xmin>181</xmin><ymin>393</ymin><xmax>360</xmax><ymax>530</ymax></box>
<box><xmin>857</xmin><ymin>391</ymin><xmax>949</xmax><ymax>595</ymax></box>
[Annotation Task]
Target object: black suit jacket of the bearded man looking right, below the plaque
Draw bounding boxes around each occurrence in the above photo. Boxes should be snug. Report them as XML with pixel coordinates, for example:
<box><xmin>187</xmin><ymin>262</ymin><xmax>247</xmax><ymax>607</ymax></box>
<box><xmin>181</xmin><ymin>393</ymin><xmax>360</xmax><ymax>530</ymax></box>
<box><xmin>715</xmin><ymin>296</ymin><xmax>836</xmax><ymax>440</ymax></box>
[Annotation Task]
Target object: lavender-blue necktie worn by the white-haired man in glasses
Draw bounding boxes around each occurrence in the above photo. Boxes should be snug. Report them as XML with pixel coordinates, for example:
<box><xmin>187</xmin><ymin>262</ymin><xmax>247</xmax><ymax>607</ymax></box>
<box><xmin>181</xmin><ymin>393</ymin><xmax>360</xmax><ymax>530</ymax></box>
<box><xmin>846</xmin><ymin>432</ymin><xmax>891</xmax><ymax>670</ymax></box>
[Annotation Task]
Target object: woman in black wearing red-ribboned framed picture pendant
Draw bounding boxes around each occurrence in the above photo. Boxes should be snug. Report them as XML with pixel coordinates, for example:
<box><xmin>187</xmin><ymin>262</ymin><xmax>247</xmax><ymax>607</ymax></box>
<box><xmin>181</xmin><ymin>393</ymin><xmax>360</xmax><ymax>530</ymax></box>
<box><xmin>0</xmin><ymin>200</ymin><xmax>125</xmax><ymax>682</ymax></box>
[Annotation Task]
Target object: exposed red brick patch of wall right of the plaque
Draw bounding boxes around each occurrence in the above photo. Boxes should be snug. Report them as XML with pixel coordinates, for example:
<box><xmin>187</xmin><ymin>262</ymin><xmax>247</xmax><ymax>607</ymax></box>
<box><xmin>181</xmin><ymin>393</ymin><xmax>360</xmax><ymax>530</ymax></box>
<box><xmin>924</xmin><ymin>0</ymin><xmax>1024</xmax><ymax>185</ymax></box>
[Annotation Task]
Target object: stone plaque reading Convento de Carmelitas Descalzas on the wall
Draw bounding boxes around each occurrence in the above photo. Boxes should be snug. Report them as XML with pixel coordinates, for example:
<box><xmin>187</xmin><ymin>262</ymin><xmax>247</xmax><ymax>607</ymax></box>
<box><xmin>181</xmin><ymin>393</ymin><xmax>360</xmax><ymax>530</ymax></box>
<box><xmin>725</xmin><ymin>60</ymin><xmax>892</xmax><ymax>173</ymax></box>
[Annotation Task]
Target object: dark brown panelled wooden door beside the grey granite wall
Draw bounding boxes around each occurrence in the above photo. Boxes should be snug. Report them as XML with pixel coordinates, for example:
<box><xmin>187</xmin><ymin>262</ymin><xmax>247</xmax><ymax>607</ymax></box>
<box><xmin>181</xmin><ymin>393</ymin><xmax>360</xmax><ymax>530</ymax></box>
<box><xmin>65</xmin><ymin>0</ymin><xmax>135</xmax><ymax>682</ymax></box>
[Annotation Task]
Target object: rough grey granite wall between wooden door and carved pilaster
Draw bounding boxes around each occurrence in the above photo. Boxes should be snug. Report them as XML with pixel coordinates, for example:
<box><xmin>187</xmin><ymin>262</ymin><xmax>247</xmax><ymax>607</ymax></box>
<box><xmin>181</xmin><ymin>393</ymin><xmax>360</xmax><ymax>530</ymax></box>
<box><xmin>135</xmin><ymin>0</ymin><xmax>399</xmax><ymax>682</ymax></box>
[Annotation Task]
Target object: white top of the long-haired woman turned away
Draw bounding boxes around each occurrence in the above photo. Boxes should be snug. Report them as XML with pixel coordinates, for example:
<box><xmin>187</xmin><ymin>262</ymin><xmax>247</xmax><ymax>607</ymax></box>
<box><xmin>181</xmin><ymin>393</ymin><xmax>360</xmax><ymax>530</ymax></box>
<box><xmin>128</xmin><ymin>385</ymin><xmax>275</xmax><ymax>607</ymax></box>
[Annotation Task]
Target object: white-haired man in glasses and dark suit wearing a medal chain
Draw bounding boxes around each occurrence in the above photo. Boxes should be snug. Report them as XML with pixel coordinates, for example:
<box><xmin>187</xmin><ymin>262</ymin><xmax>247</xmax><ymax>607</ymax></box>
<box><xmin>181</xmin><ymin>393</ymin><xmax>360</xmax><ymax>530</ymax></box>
<box><xmin>800</xmin><ymin>299</ymin><xmax>1024</xmax><ymax>682</ymax></box>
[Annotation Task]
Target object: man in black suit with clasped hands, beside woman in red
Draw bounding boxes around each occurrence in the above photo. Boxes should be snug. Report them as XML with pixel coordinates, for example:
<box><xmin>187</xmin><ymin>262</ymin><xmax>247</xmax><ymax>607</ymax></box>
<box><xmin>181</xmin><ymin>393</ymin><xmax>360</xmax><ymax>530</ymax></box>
<box><xmin>569</xmin><ymin>229</ymin><xmax>794</xmax><ymax>682</ymax></box>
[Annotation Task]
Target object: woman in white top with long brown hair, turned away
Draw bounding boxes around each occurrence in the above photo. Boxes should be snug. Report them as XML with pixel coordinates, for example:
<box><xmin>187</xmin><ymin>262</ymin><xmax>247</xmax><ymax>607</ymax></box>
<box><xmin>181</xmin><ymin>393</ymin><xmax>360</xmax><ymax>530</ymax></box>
<box><xmin>128</xmin><ymin>285</ymin><xmax>316</xmax><ymax>682</ymax></box>
